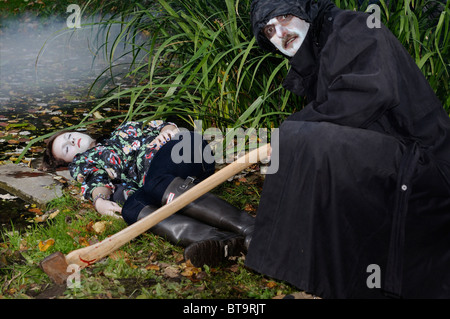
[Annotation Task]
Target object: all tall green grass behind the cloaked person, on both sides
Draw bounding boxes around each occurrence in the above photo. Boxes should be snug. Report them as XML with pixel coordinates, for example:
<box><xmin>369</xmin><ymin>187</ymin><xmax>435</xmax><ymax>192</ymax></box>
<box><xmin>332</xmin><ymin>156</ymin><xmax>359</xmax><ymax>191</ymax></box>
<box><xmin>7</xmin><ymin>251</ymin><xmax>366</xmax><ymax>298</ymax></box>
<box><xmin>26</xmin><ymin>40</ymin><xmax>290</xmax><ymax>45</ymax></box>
<box><xmin>81</xmin><ymin>0</ymin><xmax>450</xmax><ymax>134</ymax></box>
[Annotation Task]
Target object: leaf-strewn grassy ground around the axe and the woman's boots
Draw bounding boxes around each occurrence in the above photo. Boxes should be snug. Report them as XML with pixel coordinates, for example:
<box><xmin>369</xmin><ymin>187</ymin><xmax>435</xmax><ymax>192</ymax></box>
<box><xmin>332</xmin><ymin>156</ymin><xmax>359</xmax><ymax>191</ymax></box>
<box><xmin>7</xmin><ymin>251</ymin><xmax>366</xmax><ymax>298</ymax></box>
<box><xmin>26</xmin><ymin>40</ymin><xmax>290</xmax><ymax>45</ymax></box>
<box><xmin>0</xmin><ymin>173</ymin><xmax>295</xmax><ymax>299</ymax></box>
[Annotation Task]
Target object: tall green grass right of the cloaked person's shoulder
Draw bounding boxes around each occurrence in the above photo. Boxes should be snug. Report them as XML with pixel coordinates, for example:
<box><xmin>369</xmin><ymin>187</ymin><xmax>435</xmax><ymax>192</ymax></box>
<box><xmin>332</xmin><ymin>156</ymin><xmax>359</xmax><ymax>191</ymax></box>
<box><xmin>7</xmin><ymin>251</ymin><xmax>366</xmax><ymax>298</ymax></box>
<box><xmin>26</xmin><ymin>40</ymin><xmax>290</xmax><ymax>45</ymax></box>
<box><xmin>381</xmin><ymin>0</ymin><xmax>450</xmax><ymax>107</ymax></box>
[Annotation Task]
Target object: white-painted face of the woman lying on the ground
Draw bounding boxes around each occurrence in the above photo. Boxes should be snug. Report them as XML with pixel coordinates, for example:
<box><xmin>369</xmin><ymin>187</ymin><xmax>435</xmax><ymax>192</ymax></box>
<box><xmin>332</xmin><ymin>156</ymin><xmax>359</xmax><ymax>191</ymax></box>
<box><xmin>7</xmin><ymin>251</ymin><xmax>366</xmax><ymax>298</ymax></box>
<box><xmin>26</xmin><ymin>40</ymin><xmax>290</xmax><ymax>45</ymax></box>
<box><xmin>52</xmin><ymin>132</ymin><xmax>95</xmax><ymax>163</ymax></box>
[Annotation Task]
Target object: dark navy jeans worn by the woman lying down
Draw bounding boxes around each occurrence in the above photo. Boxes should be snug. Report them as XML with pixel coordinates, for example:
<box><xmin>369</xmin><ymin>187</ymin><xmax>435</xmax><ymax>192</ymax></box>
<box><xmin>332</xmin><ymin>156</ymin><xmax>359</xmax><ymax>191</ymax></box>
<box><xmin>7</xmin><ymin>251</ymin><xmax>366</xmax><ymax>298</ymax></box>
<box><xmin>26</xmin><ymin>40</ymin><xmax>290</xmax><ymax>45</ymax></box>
<box><xmin>122</xmin><ymin>132</ymin><xmax>215</xmax><ymax>224</ymax></box>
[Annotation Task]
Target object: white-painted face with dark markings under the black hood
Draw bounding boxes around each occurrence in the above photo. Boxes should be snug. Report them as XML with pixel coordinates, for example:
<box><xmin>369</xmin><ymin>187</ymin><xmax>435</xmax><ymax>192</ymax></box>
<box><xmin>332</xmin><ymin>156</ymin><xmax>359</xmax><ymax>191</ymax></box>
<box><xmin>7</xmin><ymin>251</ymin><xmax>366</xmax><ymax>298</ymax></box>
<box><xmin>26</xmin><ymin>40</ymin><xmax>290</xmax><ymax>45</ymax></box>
<box><xmin>263</xmin><ymin>14</ymin><xmax>309</xmax><ymax>57</ymax></box>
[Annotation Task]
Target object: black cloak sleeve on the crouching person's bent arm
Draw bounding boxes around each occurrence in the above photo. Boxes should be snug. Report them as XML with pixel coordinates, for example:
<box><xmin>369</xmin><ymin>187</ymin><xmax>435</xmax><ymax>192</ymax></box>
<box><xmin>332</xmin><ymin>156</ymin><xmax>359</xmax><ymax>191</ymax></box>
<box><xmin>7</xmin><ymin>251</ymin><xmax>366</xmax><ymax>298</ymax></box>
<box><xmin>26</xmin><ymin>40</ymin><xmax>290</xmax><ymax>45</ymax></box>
<box><xmin>288</xmin><ymin>12</ymin><xmax>401</xmax><ymax>128</ymax></box>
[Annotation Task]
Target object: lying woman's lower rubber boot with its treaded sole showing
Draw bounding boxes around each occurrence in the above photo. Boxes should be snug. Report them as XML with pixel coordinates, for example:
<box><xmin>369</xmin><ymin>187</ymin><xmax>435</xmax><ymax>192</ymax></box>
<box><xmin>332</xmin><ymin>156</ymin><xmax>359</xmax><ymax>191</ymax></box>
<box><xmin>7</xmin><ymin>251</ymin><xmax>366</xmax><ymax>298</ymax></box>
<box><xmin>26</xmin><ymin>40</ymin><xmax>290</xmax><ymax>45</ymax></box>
<box><xmin>138</xmin><ymin>205</ymin><xmax>246</xmax><ymax>267</ymax></box>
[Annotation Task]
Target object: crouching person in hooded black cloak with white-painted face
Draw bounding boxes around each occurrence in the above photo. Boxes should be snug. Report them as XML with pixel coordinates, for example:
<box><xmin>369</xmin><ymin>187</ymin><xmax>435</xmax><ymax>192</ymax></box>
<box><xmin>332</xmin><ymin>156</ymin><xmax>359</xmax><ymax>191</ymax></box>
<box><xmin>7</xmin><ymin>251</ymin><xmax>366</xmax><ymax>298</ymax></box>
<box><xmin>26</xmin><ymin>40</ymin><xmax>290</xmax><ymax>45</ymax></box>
<box><xmin>246</xmin><ymin>0</ymin><xmax>450</xmax><ymax>298</ymax></box>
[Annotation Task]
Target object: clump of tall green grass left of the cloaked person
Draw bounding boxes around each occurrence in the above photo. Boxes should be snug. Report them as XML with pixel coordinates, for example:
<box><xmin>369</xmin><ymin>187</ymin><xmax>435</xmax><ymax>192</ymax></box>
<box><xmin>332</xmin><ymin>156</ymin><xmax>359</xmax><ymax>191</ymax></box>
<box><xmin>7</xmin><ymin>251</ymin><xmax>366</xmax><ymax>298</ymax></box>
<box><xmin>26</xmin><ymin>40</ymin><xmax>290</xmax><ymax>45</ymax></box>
<box><xmin>83</xmin><ymin>0</ymin><xmax>301</xmax><ymax>129</ymax></box>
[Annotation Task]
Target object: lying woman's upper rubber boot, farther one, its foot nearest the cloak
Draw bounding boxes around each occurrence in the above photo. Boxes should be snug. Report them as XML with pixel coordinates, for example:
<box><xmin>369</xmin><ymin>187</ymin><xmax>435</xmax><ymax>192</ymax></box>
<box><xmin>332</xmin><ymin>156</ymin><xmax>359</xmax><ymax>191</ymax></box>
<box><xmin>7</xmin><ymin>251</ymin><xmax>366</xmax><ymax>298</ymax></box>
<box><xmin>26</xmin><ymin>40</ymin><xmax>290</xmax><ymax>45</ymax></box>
<box><xmin>162</xmin><ymin>177</ymin><xmax>255</xmax><ymax>248</ymax></box>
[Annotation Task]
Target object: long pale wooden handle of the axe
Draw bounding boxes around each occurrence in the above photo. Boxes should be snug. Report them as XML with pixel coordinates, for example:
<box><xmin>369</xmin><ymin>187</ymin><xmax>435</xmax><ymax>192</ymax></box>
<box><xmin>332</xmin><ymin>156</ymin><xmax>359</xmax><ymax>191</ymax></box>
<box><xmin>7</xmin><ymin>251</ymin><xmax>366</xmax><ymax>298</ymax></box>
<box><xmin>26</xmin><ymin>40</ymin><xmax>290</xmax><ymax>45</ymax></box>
<box><xmin>61</xmin><ymin>144</ymin><xmax>270</xmax><ymax>268</ymax></box>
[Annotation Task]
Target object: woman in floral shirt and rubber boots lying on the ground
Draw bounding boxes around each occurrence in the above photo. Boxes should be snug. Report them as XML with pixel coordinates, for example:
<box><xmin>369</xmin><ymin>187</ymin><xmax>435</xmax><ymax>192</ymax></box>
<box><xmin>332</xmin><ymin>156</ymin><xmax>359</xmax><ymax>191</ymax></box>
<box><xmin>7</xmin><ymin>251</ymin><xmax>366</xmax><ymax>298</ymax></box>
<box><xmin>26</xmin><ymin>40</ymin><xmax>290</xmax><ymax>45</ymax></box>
<box><xmin>41</xmin><ymin>121</ymin><xmax>254</xmax><ymax>267</ymax></box>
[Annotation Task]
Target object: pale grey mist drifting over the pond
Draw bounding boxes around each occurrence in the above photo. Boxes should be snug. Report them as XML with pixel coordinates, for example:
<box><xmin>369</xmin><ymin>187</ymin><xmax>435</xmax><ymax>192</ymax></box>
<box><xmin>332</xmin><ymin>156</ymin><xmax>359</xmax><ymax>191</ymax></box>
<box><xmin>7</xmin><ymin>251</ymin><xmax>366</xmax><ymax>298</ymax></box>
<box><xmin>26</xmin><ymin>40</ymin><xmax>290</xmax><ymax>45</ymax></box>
<box><xmin>0</xmin><ymin>14</ymin><xmax>143</xmax><ymax>112</ymax></box>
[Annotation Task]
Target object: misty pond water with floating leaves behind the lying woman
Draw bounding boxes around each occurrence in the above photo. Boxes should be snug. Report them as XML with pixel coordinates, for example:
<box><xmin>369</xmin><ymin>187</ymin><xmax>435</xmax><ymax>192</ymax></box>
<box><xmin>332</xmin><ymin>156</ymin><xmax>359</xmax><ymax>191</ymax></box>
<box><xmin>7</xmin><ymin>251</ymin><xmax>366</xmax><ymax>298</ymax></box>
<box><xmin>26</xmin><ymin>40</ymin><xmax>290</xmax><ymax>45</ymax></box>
<box><xmin>0</xmin><ymin>15</ymin><xmax>144</xmax><ymax>229</ymax></box>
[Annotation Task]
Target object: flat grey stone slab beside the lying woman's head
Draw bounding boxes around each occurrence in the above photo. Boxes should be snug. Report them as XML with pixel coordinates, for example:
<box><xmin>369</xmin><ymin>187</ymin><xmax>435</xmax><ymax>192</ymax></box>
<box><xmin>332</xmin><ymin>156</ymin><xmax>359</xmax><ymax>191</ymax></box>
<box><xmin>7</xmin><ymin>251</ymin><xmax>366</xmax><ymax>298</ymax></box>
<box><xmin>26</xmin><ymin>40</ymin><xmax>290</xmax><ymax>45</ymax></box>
<box><xmin>0</xmin><ymin>164</ymin><xmax>65</xmax><ymax>208</ymax></box>
